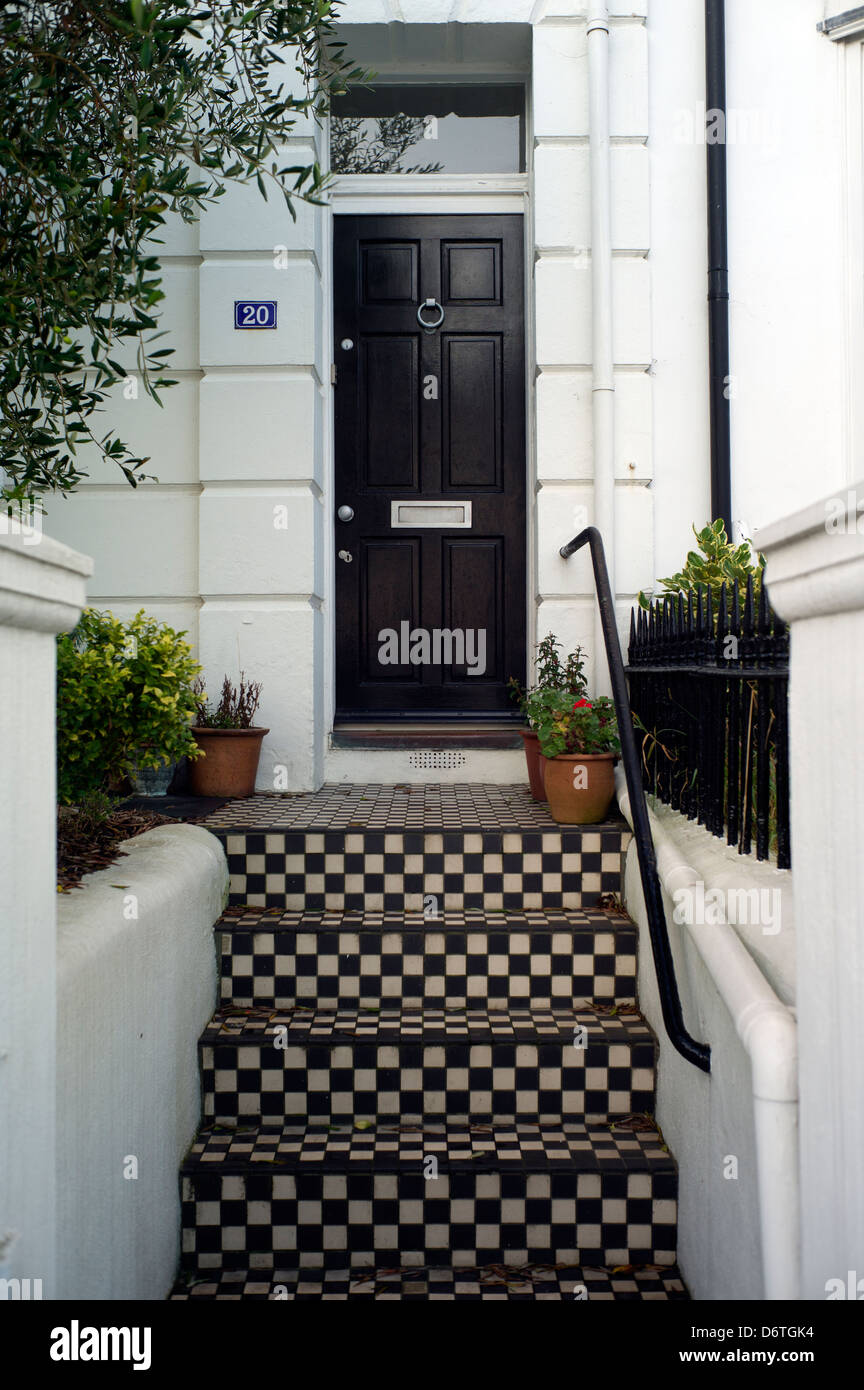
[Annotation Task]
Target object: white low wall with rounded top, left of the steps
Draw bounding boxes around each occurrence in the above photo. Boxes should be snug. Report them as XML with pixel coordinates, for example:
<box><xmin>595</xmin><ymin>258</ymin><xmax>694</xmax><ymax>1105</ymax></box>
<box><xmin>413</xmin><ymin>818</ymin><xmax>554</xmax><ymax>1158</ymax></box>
<box><xmin>54</xmin><ymin>826</ymin><xmax>228</xmax><ymax>1300</ymax></box>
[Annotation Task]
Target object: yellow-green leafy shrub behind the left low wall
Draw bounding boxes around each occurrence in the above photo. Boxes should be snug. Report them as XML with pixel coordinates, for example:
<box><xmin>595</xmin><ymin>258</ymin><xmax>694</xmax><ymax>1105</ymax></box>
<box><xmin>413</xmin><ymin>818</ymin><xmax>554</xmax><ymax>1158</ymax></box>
<box><xmin>57</xmin><ymin>609</ymin><xmax>200</xmax><ymax>803</ymax></box>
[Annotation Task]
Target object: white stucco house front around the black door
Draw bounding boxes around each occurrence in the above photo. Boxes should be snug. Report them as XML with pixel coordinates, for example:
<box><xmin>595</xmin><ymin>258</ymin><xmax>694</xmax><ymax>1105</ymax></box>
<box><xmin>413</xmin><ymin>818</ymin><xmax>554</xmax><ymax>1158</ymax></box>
<box><xmin>35</xmin><ymin>0</ymin><xmax>864</xmax><ymax>790</ymax></box>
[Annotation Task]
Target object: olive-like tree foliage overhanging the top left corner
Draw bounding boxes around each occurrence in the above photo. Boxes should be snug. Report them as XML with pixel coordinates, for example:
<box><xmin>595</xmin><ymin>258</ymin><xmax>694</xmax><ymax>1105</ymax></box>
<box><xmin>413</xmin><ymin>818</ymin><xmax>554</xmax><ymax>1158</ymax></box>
<box><xmin>0</xmin><ymin>0</ymin><xmax>363</xmax><ymax>500</ymax></box>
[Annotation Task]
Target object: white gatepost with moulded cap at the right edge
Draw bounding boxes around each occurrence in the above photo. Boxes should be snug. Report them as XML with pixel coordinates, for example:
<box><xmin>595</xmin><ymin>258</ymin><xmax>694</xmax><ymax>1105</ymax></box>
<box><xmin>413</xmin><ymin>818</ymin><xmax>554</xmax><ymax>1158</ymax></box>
<box><xmin>758</xmin><ymin>477</ymin><xmax>864</xmax><ymax>1300</ymax></box>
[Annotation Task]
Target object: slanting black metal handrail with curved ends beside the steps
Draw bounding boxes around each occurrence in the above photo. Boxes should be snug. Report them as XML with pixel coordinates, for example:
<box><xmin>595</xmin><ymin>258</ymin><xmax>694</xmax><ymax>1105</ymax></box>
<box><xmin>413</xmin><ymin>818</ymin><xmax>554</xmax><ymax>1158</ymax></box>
<box><xmin>560</xmin><ymin>525</ymin><xmax>711</xmax><ymax>1072</ymax></box>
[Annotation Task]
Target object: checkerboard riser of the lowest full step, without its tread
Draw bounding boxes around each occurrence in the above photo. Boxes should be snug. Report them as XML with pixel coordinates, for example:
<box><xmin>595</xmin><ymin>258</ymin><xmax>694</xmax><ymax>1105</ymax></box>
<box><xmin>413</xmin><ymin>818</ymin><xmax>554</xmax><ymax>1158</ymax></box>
<box><xmin>182</xmin><ymin>1170</ymin><xmax>676</xmax><ymax>1272</ymax></box>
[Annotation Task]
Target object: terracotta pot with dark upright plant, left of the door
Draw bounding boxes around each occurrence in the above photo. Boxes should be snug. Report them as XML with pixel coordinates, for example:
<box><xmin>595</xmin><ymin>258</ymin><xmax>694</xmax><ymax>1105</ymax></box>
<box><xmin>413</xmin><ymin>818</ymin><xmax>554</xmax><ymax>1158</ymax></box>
<box><xmin>189</xmin><ymin>671</ymin><xmax>269</xmax><ymax>796</ymax></box>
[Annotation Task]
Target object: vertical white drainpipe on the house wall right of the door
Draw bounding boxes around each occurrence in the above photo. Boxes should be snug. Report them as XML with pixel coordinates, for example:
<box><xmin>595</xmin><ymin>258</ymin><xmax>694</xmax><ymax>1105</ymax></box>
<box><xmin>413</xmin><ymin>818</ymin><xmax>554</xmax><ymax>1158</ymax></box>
<box><xmin>588</xmin><ymin>0</ymin><xmax>617</xmax><ymax>695</ymax></box>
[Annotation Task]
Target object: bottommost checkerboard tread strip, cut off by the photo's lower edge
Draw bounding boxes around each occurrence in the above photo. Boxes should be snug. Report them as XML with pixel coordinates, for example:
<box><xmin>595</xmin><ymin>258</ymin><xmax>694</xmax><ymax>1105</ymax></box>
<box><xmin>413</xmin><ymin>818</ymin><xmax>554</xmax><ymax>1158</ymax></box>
<box><xmin>171</xmin><ymin>1265</ymin><xmax>688</xmax><ymax>1302</ymax></box>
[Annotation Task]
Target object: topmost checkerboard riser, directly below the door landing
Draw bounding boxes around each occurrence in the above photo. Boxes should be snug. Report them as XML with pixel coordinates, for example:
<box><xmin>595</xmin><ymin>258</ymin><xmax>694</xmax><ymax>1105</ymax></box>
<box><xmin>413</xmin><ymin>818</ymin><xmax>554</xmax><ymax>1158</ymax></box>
<box><xmin>219</xmin><ymin>828</ymin><xmax>629</xmax><ymax>915</ymax></box>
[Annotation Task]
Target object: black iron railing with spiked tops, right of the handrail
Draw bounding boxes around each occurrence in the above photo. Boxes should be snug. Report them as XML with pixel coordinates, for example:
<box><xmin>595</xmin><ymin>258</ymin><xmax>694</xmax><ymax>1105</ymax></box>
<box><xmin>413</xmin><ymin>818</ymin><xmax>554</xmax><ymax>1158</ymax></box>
<box><xmin>628</xmin><ymin>580</ymin><xmax>790</xmax><ymax>869</ymax></box>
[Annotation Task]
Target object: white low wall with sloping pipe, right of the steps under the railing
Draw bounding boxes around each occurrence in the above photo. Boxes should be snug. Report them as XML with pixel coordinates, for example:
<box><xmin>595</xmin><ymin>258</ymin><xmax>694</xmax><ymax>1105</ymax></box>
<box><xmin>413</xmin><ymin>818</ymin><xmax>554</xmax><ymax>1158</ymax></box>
<box><xmin>615</xmin><ymin>769</ymin><xmax>800</xmax><ymax>1301</ymax></box>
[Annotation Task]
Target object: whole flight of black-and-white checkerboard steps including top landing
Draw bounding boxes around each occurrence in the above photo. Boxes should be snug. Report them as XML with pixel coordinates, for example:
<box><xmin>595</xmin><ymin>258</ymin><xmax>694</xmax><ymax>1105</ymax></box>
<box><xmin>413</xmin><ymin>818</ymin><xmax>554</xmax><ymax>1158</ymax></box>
<box><xmin>172</xmin><ymin>787</ymin><xmax>686</xmax><ymax>1301</ymax></box>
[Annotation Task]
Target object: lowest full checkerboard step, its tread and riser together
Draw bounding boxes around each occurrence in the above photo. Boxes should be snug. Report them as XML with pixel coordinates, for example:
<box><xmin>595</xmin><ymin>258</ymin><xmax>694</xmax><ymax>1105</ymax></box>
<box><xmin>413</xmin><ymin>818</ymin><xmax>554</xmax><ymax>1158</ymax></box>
<box><xmin>181</xmin><ymin>1122</ymin><xmax>678</xmax><ymax>1272</ymax></box>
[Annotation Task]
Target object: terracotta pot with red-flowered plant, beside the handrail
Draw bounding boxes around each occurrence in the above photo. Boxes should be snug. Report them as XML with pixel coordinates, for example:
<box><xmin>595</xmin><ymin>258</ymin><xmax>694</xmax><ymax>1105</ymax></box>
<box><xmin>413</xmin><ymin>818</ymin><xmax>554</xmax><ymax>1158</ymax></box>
<box><xmin>536</xmin><ymin>691</ymin><xmax>621</xmax><ymax>826</ymax></box>
